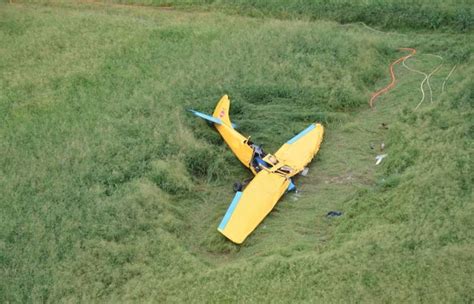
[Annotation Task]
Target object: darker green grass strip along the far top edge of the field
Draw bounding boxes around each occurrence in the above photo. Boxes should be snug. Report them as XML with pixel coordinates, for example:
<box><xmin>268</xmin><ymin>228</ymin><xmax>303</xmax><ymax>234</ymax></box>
<box><xmin>108</xmin><ymin>0</ymin><xmax>474</xmax><ymax>32</ymax></box>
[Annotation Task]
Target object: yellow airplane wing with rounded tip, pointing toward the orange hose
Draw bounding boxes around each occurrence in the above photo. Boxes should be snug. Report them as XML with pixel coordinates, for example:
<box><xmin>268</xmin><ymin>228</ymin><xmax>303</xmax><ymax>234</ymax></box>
<box><xmin>275</xmin><ymin>124</ymin><xmax>324</xmax><ymax>171</ymax></box>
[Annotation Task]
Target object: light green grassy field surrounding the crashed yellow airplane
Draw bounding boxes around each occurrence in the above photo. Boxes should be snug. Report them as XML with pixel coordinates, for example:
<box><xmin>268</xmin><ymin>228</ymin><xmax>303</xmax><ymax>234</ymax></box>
<box><xmin>0</xmin><ymin>1</ymin><xmax>474</xmax><ymax>303</ymax></box>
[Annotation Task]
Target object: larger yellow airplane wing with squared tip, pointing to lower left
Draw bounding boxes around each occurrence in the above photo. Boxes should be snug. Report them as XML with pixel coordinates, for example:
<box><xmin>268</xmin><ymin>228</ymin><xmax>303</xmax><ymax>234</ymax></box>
<box><xmin>217</xmin><ymin>170</ymin><xmax>290</xmax><ymax>244</ymax></box>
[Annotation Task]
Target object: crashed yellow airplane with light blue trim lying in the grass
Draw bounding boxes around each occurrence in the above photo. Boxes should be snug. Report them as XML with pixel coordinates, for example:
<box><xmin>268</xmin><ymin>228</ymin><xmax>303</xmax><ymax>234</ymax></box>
<box><xmin>191</xmin><ymin>95</ymin><xmax>324</xmax><ymax>244</ymax></box>
